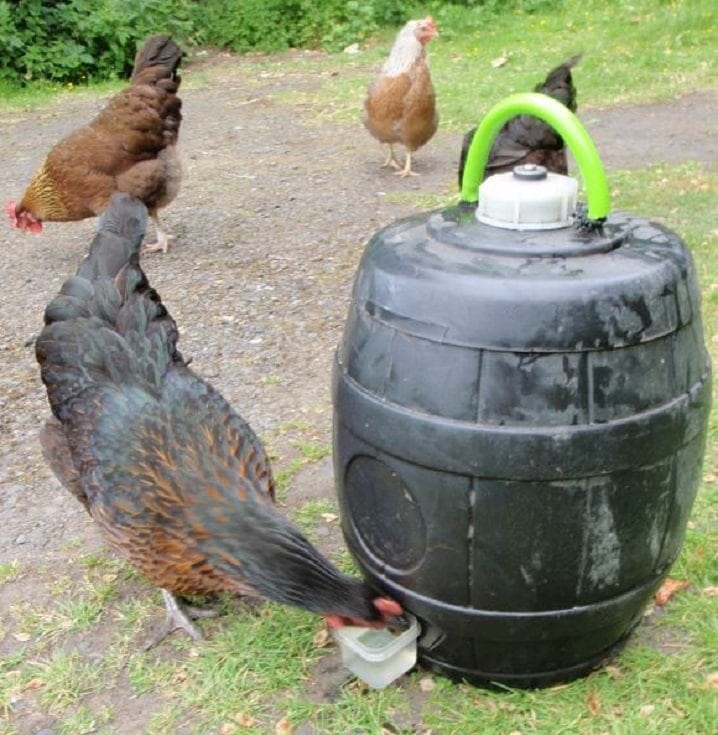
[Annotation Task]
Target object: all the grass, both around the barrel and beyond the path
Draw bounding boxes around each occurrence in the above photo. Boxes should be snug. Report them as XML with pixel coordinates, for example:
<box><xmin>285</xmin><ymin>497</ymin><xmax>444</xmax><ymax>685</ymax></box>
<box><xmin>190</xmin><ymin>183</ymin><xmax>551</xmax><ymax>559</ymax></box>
<box><xmin>0</xmin><ymin>0</ymin><xmax>718</xmax><ymax>735</ymax></box>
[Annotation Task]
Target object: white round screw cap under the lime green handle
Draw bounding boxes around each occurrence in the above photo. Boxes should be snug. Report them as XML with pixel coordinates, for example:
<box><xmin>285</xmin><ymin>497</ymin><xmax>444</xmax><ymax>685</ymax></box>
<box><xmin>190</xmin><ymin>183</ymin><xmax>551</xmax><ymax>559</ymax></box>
<box><xmin>476</xmin><ymin>163</ymin><xmax>578</xmax><ymax>230</ymax></box>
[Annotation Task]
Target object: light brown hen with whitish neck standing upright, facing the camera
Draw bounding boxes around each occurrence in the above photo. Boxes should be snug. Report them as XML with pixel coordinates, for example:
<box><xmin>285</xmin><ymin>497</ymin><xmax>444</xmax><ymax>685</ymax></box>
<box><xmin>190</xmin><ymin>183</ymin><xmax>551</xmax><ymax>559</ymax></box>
<box><xmin>362</xmin><ymin>16</ymin><xmax>439</xmax><ymax>176</ymax></box>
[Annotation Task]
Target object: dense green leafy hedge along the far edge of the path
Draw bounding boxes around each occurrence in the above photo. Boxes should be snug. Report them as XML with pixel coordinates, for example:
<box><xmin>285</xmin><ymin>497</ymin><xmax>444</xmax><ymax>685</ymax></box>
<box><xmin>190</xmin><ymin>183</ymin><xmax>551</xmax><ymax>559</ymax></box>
<box><xmin>0</xmin><ymin>0</ymin><xmax>430</xmax><ymax>85</ymax></box>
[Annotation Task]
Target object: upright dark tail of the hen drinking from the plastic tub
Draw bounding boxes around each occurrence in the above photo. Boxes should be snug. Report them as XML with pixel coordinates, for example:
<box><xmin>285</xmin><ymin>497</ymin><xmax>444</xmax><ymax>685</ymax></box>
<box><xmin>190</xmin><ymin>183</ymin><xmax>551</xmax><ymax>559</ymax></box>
<box><xmin>35</xmin><ymin>193</ymin><xmax>181</xmax><ymax>420</ymax></box>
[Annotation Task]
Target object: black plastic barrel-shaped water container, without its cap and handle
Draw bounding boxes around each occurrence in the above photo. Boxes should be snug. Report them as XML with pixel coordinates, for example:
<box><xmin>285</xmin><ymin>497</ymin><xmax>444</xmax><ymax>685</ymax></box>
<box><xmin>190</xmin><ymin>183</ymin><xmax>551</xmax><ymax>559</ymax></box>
<box><xmin>333</xmin><ymin>208</ymin><xmax>710</xmax><ymax>686</ymax></box>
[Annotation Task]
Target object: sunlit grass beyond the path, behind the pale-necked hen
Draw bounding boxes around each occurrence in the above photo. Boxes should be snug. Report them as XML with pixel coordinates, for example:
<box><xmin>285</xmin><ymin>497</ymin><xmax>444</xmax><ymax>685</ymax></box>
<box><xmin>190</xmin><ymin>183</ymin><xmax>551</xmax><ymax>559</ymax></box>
<box><xmin>269</xmin><ymin>0</ymin><xmax>718</xmax><ymax>132</ymax></box>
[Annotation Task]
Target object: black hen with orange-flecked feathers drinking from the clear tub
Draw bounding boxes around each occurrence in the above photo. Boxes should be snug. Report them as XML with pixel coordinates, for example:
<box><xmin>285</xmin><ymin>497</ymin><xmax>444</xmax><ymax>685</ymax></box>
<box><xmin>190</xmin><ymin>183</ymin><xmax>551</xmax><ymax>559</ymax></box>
<box><xmin>36</xmin><ymin>194</ymin><xmax>401</xmax><ymax>648</ymax></box>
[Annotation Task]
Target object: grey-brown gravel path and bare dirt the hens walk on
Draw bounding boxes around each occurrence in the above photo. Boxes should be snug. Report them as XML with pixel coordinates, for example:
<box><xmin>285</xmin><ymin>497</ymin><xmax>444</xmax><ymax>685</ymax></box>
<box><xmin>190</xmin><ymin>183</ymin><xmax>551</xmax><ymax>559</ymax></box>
<box><xmin>0</xmin><ymin>49</ymin><xmax>718</xmax><ymax>733</ymax></box>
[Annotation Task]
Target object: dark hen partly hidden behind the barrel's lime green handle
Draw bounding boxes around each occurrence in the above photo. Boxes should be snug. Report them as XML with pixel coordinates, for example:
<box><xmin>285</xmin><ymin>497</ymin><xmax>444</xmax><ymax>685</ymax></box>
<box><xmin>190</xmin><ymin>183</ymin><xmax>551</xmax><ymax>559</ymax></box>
<box><xmin>459</xmin><ymin>54</ymin><xmax>581</xmax><ymax>188</ymax></box>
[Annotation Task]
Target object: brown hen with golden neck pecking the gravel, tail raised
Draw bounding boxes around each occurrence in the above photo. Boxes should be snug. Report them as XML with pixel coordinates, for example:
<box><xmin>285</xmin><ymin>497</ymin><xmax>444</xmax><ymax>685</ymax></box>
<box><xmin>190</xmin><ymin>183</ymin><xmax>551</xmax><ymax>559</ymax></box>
<box><xmin>7</xmin><ymin>35</ymin><xmax>182</xmax><ymax>252</ymax></box>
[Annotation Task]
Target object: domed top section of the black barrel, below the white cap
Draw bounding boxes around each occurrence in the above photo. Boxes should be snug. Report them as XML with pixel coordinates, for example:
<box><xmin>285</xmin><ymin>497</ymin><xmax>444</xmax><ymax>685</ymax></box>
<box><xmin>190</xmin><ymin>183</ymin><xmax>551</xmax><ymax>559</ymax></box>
<box><xmin>353</xmin><ymin>207</ymin><xmax>700</xmax><ymax>352</ymax></box>
